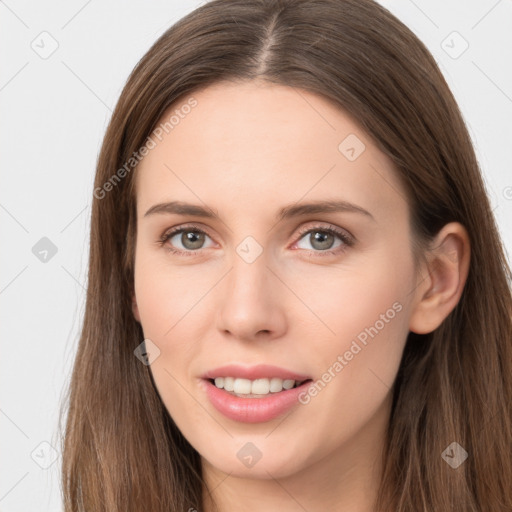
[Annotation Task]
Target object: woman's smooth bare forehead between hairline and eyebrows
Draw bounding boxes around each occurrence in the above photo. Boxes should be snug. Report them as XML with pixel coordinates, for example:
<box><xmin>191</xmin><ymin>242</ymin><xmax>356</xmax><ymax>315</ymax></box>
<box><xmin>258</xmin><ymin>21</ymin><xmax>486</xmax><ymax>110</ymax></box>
<box><xmin>136</xmin><ymin>82</ymin><xmax>407</xmax><ymax>224</ymax></box>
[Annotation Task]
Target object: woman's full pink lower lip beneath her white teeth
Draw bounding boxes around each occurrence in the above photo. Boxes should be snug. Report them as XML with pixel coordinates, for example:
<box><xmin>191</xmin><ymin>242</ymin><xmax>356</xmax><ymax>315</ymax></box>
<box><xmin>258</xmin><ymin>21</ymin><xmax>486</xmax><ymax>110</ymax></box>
<box><xmin>203</xmin><ymin>379</ymin><xmax>312</xmax><ymax>423</ymax></box>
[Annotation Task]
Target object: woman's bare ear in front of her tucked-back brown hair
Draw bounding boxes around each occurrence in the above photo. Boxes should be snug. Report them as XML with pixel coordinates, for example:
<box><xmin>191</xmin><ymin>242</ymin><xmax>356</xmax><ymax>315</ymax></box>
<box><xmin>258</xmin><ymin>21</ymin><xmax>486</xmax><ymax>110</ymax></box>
<box><xmin>409</xmin><ymin>222</ymin><xmax>471</xmax><ymax>334</ymax></box>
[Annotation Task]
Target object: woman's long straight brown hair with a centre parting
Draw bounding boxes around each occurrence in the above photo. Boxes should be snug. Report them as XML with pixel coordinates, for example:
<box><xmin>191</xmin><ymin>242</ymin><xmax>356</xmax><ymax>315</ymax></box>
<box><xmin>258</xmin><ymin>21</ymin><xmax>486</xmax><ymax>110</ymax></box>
<box><xmin>62</xmin><ymin>0</ymin><xmax>512</xmax><ymax>512</ymax></box>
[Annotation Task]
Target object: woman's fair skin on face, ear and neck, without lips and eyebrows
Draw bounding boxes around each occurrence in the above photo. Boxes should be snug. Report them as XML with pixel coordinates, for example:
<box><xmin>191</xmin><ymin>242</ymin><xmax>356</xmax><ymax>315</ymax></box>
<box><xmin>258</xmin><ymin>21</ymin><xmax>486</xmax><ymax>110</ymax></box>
<box><xmin>133</xmin><ymin>81</ymin><xmax>469</xmax><ymax>512</ymax></box>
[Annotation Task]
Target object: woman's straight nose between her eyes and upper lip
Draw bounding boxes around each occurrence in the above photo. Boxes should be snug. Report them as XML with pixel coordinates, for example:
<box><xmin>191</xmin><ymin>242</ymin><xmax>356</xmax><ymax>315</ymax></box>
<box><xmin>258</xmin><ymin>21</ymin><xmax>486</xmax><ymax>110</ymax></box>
<box><xmin>217</xmin><ymin>252</ymin><xmax>287</xmax><ymax>341</ymax></box>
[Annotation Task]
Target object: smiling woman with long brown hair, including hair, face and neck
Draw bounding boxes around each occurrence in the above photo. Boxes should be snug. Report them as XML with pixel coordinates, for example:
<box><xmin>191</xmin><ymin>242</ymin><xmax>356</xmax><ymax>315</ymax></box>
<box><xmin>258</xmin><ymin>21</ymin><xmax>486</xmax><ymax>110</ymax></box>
<box><xmin>63</xmin><ymin>0</ymin><xmax>512</xmax><ymax>512</ymax></box>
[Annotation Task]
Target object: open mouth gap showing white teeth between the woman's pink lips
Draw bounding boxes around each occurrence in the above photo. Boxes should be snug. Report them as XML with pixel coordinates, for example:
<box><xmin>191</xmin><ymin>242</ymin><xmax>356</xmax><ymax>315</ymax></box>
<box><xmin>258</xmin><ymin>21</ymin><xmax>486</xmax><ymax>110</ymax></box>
<box><xmin>206</xmin><ymin>376</ymin><xmax>311</xmax><ymax>398</ymax></box>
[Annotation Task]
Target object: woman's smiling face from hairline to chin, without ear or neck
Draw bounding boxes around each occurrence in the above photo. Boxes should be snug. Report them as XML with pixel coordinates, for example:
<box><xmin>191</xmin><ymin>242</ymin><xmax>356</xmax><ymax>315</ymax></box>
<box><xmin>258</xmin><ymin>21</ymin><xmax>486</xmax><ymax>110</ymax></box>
<box><xmin>134</xmin><ymin>82</ymin><xmax>417</xmax><ymax>478</ymax></box>
